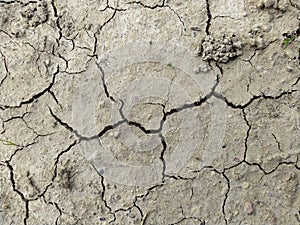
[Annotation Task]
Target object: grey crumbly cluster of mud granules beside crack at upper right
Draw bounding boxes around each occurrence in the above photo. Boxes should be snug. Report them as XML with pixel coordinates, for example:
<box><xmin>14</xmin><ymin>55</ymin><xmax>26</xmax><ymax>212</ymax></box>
<box><xmin>202</xmin><ymin>34</ymin><xmax>243</xmax><ymax>63</ymax></box>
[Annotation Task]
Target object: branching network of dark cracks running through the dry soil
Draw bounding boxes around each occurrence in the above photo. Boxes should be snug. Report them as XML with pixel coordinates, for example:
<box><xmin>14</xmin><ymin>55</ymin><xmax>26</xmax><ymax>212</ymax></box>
<box><xmin>0</xmin><ymin>0</ymin><xmax>300</xmax><ymax>225</ymax></box>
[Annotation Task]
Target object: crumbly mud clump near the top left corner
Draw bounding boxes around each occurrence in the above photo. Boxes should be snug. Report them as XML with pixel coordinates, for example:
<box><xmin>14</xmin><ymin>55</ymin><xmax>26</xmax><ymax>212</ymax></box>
<box><xmin>21</xmin><ymin>1</ymin><xmax>48</xmax><ymax>27</ymax></box>
